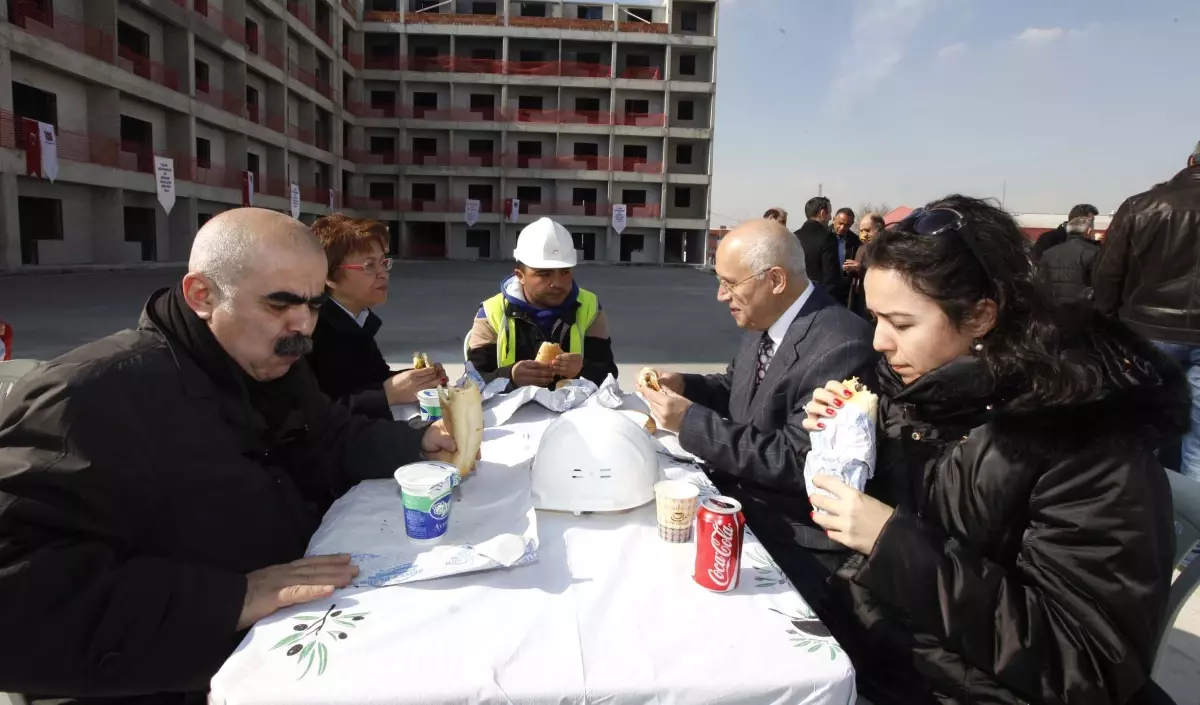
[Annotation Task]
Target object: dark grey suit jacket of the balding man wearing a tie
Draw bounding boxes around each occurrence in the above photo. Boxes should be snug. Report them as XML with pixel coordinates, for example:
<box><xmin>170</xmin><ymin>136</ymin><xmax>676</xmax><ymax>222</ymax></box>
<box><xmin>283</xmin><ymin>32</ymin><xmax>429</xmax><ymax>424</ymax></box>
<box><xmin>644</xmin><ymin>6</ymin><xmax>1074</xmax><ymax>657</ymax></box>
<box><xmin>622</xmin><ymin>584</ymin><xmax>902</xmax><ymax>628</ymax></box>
<box><xmin>679</xmin><ymin>284</ymin><xmax>876</xmax><ymax>552</ymax></box>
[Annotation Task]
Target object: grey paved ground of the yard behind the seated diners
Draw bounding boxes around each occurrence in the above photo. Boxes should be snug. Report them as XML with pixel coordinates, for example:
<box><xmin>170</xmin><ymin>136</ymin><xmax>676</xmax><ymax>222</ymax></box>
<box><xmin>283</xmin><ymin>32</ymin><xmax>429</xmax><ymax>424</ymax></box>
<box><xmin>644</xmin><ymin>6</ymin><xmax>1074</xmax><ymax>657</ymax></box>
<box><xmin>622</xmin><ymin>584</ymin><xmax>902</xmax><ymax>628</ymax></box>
<box><xmin>0</xmin><ymin>263</ymin><xmax>1200</xmax><ymax>705</ymax></box>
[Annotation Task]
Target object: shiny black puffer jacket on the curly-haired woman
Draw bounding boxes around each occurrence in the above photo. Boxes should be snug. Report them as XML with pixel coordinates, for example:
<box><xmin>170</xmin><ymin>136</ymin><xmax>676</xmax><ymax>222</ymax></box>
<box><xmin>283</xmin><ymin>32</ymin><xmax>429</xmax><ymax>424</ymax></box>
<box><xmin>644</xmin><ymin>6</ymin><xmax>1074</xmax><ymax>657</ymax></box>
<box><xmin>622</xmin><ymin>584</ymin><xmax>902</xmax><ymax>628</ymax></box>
<box><xmin>822</xmin><ymin>315</ymin><xmax>1188</xmax><ymax>705</ymax></box>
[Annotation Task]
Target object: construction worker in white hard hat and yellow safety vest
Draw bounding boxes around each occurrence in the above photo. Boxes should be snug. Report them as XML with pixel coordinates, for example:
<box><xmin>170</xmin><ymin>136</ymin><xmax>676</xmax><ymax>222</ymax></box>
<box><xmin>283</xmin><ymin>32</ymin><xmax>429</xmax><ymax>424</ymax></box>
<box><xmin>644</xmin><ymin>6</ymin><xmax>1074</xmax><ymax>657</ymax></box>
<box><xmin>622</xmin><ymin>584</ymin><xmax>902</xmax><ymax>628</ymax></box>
<box><xmin>467</xmin><ymin>218</ymin><xmax>617</xmax><ymax>387</ymax></box>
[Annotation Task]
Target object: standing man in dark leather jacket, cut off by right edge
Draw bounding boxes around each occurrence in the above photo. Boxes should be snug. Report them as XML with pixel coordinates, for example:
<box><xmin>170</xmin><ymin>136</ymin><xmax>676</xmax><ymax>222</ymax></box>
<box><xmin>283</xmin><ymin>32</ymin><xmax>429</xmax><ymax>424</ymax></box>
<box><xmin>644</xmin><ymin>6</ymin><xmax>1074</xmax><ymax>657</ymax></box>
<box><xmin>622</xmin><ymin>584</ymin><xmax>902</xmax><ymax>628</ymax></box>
<box><xmin>1092</xmin><ymin>144</ymin><xmax>1200</xmax><ymax>481</ymax></box>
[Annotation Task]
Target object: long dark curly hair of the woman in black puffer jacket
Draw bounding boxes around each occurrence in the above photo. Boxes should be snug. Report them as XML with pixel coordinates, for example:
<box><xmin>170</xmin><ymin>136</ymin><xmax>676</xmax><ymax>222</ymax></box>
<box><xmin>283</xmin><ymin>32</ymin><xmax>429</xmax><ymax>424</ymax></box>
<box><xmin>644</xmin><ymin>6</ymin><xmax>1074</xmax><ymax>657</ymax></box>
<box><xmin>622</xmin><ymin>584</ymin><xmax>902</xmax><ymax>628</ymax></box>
<box><xmin>864</xmin><ymin>194</ymin><xmax>1100</xmax><ymax>410</ymax></box>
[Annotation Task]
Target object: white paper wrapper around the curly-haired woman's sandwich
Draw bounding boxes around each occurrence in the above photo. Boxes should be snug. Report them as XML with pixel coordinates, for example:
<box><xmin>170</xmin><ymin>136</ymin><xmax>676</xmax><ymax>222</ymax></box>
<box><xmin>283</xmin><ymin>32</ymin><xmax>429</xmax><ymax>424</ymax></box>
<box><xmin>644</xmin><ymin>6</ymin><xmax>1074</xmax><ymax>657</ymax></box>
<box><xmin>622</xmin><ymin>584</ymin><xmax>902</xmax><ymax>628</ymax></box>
<box><xmin>804</xmin><ymin>395</ymin><xmax>876</xmax><ymax>511</ymax></box>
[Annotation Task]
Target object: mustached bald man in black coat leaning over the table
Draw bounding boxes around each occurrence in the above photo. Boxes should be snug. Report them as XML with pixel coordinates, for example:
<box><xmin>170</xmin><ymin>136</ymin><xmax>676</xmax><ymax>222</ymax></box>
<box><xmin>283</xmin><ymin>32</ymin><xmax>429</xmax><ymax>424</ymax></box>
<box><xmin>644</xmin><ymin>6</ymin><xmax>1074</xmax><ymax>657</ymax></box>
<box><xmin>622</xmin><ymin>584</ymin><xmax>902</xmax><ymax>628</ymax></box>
<box><xmin>0</xmin><ymin>209</ymin><xmax>454</xmax><ymax>704</ymax></box>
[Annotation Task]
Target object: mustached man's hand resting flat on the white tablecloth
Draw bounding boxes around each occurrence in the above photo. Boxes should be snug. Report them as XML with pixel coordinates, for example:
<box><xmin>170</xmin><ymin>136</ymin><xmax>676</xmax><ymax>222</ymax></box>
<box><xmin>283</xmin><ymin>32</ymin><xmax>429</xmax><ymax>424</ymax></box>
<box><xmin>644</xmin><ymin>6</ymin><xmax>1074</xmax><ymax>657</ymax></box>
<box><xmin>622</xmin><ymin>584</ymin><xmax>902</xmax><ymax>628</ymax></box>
<box><xmin>238</xmin><ymin>555</ymin><xmax>359</xmax><ymax>632</ymax></box>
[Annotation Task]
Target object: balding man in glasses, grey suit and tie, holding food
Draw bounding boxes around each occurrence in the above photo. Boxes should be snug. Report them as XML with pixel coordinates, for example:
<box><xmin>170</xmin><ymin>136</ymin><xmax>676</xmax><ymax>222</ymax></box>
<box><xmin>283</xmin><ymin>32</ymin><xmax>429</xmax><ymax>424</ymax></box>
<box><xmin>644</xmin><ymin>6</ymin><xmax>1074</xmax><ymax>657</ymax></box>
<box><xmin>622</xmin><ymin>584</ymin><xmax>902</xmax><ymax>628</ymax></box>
<box><xmin>638</xmin><ymin>219</ymin><xmax>876</xmax><ymax>597</ymax></box>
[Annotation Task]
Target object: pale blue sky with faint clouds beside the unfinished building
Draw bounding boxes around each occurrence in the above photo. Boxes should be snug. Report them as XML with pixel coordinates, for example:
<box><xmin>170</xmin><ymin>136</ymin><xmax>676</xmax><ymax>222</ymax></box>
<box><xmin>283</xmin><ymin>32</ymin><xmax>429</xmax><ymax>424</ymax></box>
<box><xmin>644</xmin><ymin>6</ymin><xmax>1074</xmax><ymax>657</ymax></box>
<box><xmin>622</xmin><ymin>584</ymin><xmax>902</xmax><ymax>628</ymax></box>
<box><xmin>712</xmin><ymin>0</ymin><xmax>1200</xmax><ymax>227</ymax></box>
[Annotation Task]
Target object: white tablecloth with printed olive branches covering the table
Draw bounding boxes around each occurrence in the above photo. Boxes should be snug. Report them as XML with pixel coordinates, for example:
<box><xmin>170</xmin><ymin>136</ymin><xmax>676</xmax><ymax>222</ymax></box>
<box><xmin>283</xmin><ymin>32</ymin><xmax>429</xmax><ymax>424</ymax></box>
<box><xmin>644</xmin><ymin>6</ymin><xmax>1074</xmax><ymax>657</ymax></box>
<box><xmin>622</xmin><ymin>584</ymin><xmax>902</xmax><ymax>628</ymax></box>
<box><xmin>210</xmin><ymin>406</ymin><xmax>854</xmax><ymax>705</ymax></box>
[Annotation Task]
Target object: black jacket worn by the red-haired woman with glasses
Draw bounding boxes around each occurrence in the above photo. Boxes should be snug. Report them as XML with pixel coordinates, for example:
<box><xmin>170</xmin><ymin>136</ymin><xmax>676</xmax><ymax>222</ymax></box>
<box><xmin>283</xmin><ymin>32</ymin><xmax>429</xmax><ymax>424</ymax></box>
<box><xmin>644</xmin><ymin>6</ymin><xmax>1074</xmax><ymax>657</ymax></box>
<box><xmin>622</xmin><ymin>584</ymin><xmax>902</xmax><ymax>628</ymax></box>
<box><xmin>308</xmin><ymin>300</ymin><xmax>396</xmax><ymax>420</ymax></box>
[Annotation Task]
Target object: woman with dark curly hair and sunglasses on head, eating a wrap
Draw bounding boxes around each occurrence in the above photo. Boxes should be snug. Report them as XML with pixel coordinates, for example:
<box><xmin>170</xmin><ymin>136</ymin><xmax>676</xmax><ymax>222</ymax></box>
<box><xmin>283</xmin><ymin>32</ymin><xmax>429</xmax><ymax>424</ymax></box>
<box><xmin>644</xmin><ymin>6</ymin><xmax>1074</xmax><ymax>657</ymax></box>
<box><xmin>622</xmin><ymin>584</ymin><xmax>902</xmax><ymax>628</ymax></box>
<box><xmin>804</xmin><ymin>195</ymin><xmax>1189</xmax><ymax>705</ymax></box>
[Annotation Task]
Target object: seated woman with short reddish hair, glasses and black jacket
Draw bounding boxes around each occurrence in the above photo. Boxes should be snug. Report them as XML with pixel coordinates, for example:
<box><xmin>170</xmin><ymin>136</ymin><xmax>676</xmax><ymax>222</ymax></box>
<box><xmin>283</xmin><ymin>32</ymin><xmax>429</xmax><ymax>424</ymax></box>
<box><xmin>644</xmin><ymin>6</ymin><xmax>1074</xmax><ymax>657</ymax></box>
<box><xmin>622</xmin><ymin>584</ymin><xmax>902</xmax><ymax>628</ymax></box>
<box><xmin>308</xmin><ymin>213</ymin><xmax>445</xmax><ymax>418</ymax></box>
